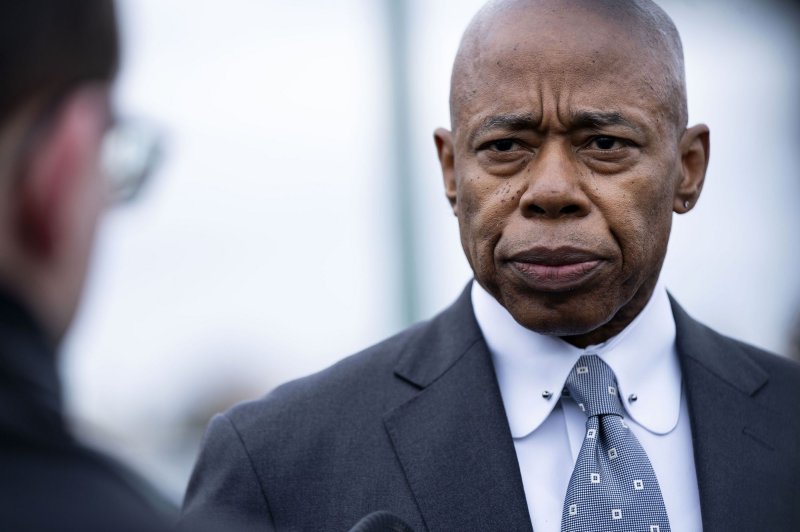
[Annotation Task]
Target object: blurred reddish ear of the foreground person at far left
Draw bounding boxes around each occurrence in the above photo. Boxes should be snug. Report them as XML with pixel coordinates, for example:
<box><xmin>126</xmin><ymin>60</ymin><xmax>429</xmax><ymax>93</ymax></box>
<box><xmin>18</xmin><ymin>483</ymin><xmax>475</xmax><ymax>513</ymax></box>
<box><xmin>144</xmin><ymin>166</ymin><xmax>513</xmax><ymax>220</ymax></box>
<box><xmin>16</xmin><ymin>89</ymin><xmax>106</xmax><ymax>259</ymax></box>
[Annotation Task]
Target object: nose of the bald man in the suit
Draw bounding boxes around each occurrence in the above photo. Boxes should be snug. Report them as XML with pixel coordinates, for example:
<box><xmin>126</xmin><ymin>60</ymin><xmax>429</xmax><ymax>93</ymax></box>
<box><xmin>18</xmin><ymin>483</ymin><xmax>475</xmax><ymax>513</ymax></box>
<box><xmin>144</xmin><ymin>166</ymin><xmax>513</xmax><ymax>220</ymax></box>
<box><xmin>519</xmin><ymin>145</ymin><xmax>591</xmax><ymax>219</ymax></box>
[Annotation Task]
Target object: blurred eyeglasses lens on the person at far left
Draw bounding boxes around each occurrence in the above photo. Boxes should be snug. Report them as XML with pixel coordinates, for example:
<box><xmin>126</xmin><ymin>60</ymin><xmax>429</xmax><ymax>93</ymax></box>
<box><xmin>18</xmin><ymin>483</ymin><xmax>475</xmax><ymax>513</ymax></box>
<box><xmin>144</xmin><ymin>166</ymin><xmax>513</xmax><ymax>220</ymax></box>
<box><xmin>100</xmin><ymin>119</ymin><xmax>164</xmax><ymax>204</ymax></box>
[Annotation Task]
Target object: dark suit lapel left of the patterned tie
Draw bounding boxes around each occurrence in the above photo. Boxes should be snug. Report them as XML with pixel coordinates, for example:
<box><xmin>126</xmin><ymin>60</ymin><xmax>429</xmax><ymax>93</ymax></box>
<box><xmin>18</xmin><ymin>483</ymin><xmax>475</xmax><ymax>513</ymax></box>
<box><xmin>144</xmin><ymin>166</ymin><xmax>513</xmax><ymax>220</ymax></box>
<box><xmin>384</xmin><ymin>288</ymin><xmax>531</xmax><ymax>531</ymax></box>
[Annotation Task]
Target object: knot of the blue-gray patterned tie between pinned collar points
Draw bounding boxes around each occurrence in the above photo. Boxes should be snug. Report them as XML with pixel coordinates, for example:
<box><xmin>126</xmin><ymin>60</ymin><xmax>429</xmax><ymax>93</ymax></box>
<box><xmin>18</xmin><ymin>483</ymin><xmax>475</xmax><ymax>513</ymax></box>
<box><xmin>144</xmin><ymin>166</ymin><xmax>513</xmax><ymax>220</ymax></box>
<box><xmin>566</xmin><ymin>355</ymin><xmax>623</xmax><ymax>417</ymax></box>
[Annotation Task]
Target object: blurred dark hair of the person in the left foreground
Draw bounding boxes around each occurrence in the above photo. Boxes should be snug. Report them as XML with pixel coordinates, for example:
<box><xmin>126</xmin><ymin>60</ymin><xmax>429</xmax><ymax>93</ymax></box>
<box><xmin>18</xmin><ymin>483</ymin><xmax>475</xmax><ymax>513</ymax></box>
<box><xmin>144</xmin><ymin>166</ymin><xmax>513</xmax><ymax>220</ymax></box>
<box><xmin>0</xmin><ymin>0</ymin><xmax>119</xmax><ymax>125</ymax></box>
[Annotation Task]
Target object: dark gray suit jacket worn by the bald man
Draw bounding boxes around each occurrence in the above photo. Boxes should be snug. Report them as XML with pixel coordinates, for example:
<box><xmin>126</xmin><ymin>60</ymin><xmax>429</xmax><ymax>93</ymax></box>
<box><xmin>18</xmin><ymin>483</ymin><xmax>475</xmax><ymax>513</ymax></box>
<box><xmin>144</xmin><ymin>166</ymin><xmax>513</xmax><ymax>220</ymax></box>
<box><xmin>184</xmin><ymin>290</ymin><xmax>800</xmax><ymax>532</ymax></box>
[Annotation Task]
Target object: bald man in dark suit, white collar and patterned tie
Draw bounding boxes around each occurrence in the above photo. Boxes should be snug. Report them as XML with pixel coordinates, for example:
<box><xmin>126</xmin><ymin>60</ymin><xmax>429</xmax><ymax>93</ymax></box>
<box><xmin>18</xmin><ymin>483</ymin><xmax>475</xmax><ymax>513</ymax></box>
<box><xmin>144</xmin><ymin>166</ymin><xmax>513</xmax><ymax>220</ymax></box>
<box><xmin>184</xmin><ymin>0</ymin><xmax>800</xmax><ymax>532</ymax></box>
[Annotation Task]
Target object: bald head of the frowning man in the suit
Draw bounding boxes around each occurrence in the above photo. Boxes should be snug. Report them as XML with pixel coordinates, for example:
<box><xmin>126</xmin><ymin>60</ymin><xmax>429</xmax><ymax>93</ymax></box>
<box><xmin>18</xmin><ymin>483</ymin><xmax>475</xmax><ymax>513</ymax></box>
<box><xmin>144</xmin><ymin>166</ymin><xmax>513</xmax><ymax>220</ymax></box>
<box><xmin>434</xmin><ymin>0</ymin><xmax>709</xmax><ymax>347</ymax></box>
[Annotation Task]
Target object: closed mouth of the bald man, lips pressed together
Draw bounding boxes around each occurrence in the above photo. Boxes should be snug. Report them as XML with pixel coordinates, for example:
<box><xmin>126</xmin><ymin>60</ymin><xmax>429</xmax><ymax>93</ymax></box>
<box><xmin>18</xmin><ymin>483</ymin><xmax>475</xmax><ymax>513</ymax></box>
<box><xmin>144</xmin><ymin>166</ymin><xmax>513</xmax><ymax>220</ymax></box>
<box><xmin>506</xmin><ymin>247</ymin><xmax>604</xmax><ymax>292</ymax></box>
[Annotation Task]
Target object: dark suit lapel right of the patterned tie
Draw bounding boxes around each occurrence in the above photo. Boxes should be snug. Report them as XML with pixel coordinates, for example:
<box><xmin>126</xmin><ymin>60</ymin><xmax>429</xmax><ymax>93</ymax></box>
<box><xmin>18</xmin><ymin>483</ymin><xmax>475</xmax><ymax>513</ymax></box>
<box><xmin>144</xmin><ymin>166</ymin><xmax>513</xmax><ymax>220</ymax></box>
<box><xmin>672</xmin><ymin>300</ymin><xmax>780</xmax><ymax>530</ymax></box>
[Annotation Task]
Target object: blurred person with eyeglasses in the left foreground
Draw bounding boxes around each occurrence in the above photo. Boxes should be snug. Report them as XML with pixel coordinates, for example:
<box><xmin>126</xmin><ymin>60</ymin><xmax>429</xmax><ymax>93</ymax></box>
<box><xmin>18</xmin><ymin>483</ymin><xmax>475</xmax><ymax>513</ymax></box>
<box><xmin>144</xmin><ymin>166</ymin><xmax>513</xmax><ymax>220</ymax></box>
<box><xmin>0</xmin><ymin>0</ymin><xmax>169</xmax><ymax>532</ymax></box>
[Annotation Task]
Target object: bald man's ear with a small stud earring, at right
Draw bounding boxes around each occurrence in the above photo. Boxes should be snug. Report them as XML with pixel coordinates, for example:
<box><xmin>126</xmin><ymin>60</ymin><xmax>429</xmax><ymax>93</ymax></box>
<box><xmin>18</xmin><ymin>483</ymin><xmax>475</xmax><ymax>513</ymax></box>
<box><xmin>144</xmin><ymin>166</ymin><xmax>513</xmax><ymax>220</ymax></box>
<box><xmin>673</xmin><ymin>124</ymin><xmax>710</xmax><ymax>214</ymax></box>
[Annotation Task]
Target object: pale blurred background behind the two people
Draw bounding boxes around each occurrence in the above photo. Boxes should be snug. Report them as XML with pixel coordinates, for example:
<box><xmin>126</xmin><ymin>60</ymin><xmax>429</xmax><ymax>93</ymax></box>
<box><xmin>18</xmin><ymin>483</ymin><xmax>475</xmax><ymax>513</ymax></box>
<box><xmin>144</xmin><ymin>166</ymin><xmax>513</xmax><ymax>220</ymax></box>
<box><xmin>62</xmin><ymin>0</ymin><xmax>800</xmax><ymax>501</ymax></box>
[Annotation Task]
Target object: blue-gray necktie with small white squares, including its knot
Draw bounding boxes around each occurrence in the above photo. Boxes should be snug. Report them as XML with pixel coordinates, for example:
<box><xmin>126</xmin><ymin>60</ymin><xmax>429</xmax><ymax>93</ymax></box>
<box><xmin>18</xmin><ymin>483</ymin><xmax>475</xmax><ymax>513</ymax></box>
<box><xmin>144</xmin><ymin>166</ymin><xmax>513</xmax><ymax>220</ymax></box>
<box><xmin>561</xmin><ymin>355</ymin><xmax>670</xmax><ymax>532</ymax></box>
